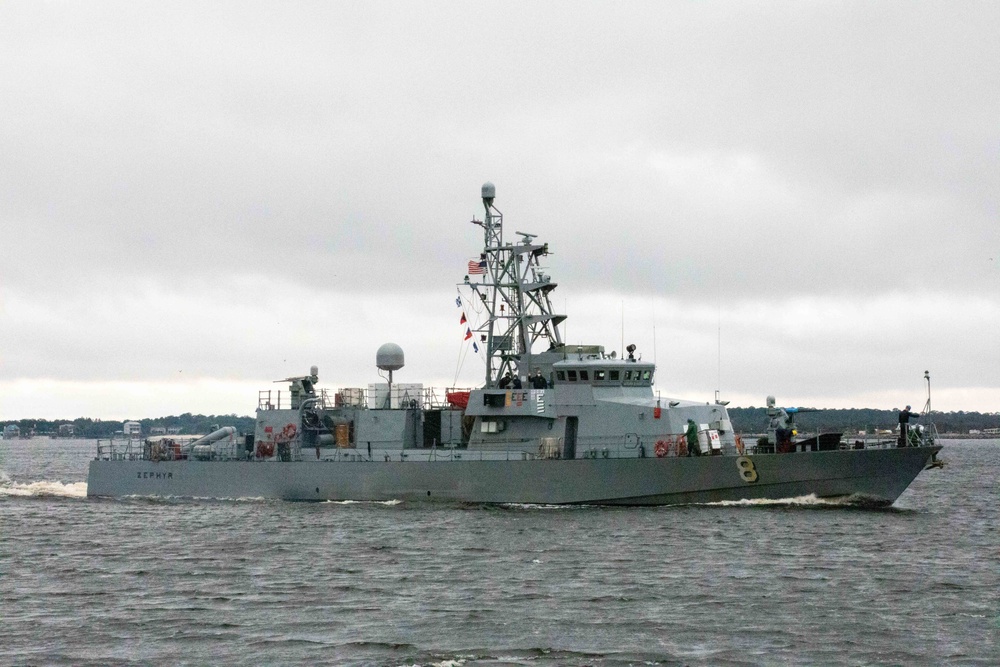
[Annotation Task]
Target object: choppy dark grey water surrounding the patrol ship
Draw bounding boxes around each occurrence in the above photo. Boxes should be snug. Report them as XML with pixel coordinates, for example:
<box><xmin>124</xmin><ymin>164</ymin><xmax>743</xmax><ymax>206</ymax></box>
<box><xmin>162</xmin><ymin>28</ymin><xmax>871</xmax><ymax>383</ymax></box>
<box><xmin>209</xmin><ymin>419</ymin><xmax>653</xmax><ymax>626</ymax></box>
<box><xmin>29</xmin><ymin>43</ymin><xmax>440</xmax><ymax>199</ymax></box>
<box><xmin>0</xmin><ymin>439</ymin><xmax>1000</xmax><ymax>667</ymax></box>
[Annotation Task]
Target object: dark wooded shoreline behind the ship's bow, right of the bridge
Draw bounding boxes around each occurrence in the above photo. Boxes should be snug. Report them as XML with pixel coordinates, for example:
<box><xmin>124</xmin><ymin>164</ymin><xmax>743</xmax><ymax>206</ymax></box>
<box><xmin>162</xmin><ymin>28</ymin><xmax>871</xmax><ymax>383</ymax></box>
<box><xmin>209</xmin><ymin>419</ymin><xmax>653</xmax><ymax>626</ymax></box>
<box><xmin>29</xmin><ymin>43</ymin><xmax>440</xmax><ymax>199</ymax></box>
<box><xmin>729</xmin><ymin>408</ymin><xmax>1000</xmax><ymax>433</ymax></box>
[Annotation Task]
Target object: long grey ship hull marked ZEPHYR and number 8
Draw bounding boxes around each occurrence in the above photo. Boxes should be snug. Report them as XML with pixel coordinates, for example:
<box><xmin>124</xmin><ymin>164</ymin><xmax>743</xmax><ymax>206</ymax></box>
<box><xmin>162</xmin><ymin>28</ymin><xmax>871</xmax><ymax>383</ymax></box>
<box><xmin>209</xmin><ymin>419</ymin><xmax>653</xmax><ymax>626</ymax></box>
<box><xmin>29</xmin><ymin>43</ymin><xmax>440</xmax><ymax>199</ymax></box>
<box><xmin>87</xmin><ymin>446</ymin><xmax>940</xmax><ymax>505</ymax></box>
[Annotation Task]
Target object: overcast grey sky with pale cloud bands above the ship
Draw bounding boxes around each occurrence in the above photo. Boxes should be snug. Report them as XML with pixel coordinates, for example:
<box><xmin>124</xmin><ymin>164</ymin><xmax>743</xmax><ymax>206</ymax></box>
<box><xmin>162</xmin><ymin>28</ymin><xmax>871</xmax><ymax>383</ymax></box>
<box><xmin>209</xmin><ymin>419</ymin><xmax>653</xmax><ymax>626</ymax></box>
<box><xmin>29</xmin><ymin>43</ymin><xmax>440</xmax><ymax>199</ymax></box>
<box><xmin>0</xmin><ymin>0</ymin><xmax>1000</xmax><ymax>420</ymax></box>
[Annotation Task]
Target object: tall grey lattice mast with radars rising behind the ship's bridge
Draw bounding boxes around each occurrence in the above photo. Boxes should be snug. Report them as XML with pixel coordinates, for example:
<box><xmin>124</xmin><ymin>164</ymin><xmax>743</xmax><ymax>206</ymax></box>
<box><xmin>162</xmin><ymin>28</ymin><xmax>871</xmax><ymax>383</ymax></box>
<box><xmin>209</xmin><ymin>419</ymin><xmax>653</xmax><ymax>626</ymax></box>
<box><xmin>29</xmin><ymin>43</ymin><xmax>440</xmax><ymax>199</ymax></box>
<box><xmin>466</xmin><ymin>183</ymin><xmax>566</xmax><ymax>387</ymax></box>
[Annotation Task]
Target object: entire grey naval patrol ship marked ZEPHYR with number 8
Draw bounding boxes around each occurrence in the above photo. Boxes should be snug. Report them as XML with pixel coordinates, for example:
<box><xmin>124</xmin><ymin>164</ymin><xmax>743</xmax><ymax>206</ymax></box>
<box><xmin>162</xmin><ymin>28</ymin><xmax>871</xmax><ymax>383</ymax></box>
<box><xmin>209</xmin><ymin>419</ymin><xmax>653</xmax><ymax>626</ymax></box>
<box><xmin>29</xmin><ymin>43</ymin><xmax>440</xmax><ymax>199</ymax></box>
<box><xmin>87</xmin><ymin>183</ymin><xmax>941</xmax><ymax>505</ymax></box>
